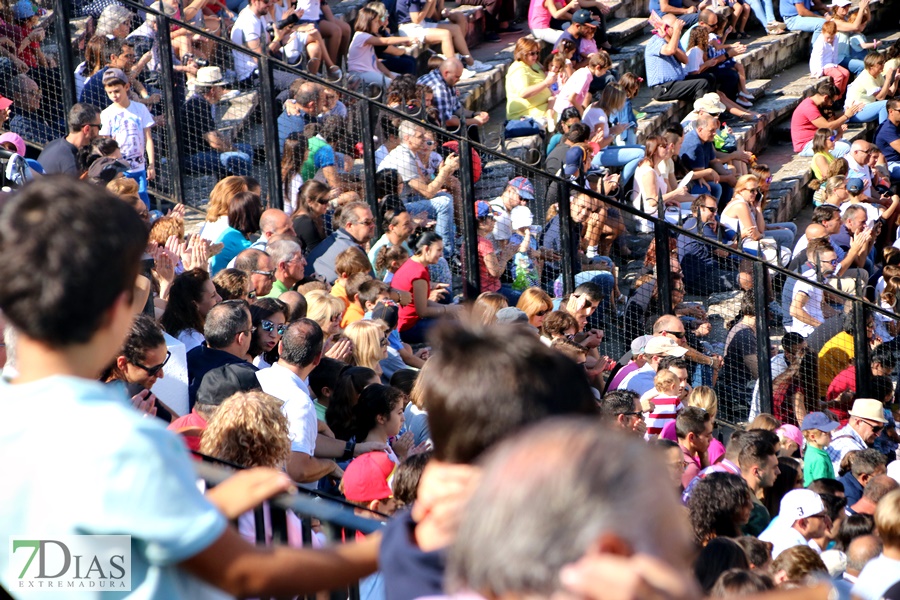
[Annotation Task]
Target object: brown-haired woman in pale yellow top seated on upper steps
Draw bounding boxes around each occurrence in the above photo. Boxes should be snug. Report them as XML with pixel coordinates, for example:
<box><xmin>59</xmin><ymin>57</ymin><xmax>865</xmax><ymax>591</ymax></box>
<box><xmin>506</xmin><ymin>37</ymin><xmax>556</xmax><ymax>123</ymax></box>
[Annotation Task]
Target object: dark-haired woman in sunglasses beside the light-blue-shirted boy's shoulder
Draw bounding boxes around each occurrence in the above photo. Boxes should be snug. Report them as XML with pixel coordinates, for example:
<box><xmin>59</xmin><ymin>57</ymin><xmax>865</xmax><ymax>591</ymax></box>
<box><xmin>103</xmin><ymin>314</ymin><xmax>177</xmax><ymax>421</ymax></box>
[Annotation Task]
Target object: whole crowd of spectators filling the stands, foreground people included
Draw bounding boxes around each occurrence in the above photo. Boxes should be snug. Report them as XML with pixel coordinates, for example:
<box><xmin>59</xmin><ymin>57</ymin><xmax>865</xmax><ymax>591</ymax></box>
<box><xmin>0</xmin><ymin>0</ymin><xmax>900</xmax><ymax>600</ymax></box>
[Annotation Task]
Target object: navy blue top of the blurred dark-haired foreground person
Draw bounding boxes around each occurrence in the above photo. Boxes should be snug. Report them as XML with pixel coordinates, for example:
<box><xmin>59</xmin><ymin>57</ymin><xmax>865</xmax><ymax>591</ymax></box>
<box><xmin>378</xmin><ymin>509</ymin><xmax>447</xmax><ymax>600</ymax></box>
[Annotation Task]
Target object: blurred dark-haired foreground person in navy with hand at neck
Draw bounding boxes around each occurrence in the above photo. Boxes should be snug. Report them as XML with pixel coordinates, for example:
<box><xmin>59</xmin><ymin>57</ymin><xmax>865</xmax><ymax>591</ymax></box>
<box><xmin>381</xmin><ymin>326</ymin><xmax>597</xmax><ymax>600</ymax></box>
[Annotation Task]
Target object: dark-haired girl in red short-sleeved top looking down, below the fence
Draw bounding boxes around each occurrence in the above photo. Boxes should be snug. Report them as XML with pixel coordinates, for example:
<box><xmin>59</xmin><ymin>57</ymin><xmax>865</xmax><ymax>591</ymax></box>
<box><xmin>391</xmin><ymin>231</ymin><xmax>460</xmax><ymax>344</ymax></box>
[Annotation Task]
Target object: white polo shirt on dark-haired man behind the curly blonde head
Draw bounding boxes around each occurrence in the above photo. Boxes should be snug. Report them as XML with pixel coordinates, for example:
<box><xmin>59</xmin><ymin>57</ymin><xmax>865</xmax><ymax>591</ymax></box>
<box><xmin>256</xmin><ymin>363</ymin><xmax>319</xmax><ymax>456</ymax></box>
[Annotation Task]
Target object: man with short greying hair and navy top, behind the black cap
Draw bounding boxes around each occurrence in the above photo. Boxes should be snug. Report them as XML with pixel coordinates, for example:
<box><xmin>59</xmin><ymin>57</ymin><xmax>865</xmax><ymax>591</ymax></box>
<box><xmin>187</xmin><ymin>300</ymin><xmax>256</xmax><ymax>408</ymax></box>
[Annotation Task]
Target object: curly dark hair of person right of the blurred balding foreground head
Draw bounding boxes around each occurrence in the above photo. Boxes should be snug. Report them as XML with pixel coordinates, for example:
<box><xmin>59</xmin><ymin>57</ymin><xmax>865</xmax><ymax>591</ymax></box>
<box><xmin>688</xmin><ymin>473</ymin><xmax>753</xmax><ymax>544</ymax></box>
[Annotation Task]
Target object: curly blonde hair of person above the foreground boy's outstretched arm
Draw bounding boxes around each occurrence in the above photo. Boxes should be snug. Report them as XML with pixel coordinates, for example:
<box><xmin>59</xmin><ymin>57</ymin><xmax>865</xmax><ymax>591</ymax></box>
<box><xmin>200</xmin><ymin>390</ymin><xmax>291</xmax><ymax>467</ymax></box>
